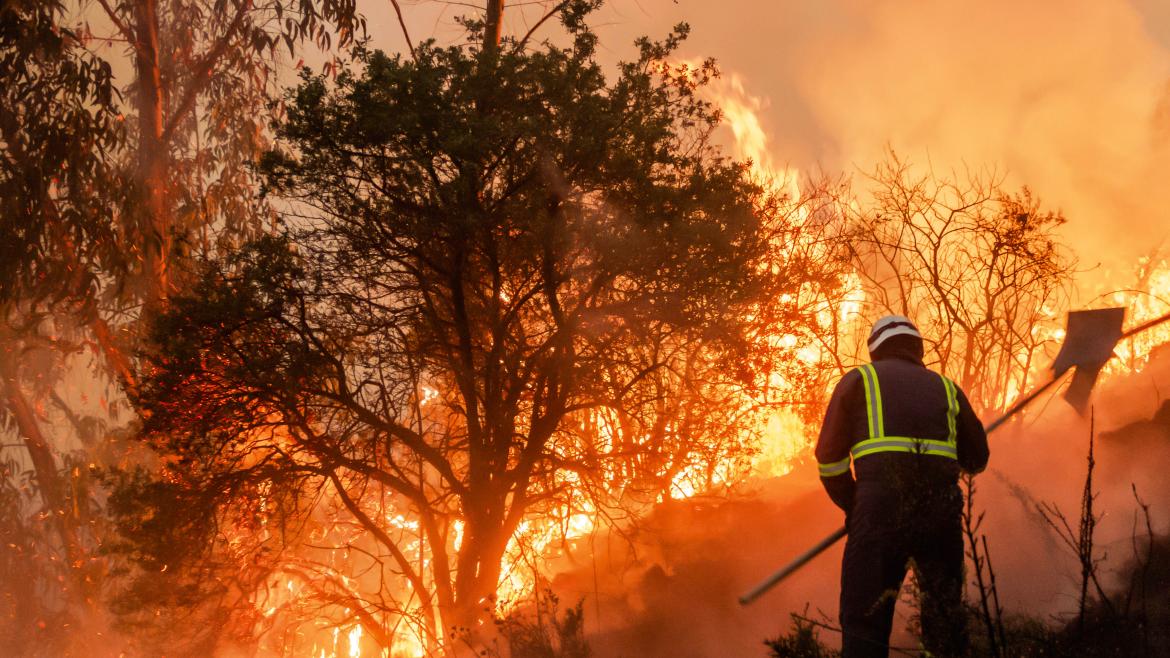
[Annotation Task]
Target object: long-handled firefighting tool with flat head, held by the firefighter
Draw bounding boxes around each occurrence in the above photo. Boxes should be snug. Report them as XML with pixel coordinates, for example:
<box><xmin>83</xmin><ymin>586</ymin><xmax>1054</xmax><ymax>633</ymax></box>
<box><xmin>739</xmin><ymin>308</ymin><xmax>1170</xmax><ymax>605</ymax></box>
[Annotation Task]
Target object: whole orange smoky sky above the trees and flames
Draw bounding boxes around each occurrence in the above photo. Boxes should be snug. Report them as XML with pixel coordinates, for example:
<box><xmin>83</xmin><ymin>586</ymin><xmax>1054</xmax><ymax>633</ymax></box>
<box><xmin>359</xmin><ymin>0</ymin><xmax>1170</xmax><ymax>278</ymax></box>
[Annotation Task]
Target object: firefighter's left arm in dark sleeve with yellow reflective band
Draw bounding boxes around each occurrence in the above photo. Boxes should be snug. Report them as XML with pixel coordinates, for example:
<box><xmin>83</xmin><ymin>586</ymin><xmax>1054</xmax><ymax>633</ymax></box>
<box><xmin>815</xmin><ymin>370</ymin><xmax>863</xmax><ymax>514</ymax></box>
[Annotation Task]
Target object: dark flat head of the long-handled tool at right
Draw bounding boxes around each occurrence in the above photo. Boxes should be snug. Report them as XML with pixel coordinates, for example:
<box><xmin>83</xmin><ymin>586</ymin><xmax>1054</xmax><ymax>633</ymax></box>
<box><xmin>1052</xmin><ymin>308</ymin><xmax>1126</xmax><ymax>414</ymax></box>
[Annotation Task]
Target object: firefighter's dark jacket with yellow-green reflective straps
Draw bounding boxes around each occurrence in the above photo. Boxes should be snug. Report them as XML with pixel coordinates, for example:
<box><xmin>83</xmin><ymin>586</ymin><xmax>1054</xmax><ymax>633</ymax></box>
<box><xmin>815</xmin><ymin>352</ymin><xmax>989</xmax><ymax>514</ymax></box>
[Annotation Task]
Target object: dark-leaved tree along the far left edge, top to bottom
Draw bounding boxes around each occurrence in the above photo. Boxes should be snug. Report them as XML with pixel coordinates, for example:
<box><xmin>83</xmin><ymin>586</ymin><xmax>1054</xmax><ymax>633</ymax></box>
<box><xmin>0</xmin><ymin>1</ymin><xmax>125</xmax><ymax>653</ymax></box>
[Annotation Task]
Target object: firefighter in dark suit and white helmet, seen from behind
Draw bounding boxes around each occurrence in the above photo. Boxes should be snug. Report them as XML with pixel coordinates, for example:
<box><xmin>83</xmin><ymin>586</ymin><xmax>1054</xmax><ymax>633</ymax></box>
<box><xmin>817</xmin><ymin>315</ymin><xmax>989</xmax><ymax>658</ymax></box>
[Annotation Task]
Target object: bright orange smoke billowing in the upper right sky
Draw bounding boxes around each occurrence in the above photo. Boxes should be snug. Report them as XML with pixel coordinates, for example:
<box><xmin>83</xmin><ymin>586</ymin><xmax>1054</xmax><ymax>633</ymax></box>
<box><xmin>796</xmin><ymin>1</ymin><xmax>1170</xmax><ymax>271</ymax></box>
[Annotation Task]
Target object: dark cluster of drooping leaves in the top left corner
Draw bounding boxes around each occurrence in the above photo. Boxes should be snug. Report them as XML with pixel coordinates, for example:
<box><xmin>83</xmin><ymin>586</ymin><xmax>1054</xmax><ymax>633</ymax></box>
<box><xmin>0</xmin><ymin>0</ymin><xmax>125</xmax><ymax>301</ymax></box>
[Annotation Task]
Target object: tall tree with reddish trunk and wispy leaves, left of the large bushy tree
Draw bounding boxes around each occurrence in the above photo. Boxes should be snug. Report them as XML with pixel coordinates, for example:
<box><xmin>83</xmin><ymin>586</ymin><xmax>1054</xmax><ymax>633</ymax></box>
<box><xmin>98</xmin><ymin>0</ymin><xmax>365</xmax><ymax>303</ymax></box>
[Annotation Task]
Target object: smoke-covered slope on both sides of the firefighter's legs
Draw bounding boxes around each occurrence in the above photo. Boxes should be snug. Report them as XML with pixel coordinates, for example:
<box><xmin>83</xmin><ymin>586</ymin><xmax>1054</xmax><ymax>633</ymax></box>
<box><xmin>538</xmin><ymin>350</ymin><xmax>1170</xmax><ymax>657</ymax></box>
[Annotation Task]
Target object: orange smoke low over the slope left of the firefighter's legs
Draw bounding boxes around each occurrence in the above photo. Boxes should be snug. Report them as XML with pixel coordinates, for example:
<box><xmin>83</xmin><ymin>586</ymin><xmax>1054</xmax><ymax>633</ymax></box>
<box><xmin>542</xmin><ymin>462</ymin><xmax>842</xmax><ymax>658</ymax></box>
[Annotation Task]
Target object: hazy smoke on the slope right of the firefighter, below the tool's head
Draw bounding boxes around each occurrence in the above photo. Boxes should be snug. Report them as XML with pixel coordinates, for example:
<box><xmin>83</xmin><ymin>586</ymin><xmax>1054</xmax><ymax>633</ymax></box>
<box><xmin>977</xmin><ymin>350</ymin><xmax>1170</xmax><ymax>615</ymax></box>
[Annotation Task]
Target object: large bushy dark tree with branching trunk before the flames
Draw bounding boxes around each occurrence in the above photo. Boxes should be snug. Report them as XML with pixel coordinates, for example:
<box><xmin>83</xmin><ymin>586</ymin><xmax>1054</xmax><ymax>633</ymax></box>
<box><xmin>125</xmin><ymin>15</ymin><xmax>793</xmax><ymax>650</ymax></box>
